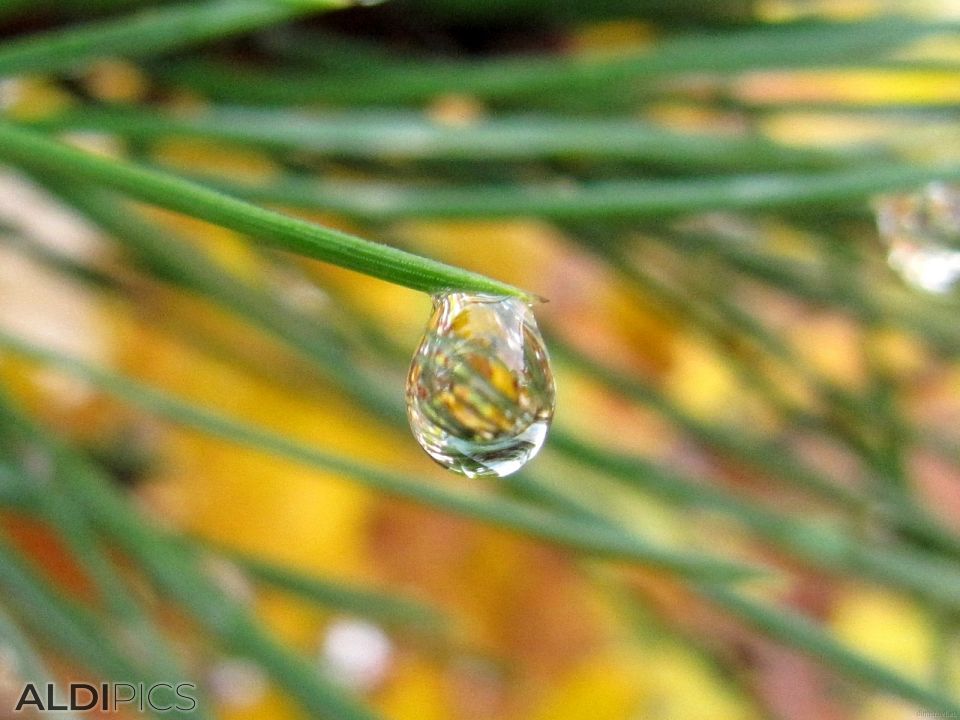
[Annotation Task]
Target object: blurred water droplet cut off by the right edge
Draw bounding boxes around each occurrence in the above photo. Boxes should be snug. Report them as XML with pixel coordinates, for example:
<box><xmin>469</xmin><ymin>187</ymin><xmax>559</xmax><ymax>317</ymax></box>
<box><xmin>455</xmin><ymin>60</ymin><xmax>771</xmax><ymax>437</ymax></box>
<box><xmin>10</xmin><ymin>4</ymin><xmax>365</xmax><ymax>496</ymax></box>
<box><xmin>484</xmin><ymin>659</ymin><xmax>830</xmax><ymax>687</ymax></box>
<box><xmin>876</xmin><ymin>182</ymin><xmax>960</xmax><ymax>293</ymax></box>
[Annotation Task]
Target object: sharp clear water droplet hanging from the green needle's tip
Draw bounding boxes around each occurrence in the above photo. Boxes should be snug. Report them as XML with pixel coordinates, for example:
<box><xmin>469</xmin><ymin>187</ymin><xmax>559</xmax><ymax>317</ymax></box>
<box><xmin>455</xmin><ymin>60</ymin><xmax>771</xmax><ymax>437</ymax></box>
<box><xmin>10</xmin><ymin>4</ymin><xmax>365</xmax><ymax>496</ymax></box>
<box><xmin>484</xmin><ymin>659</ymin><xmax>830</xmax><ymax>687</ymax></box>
<box><xmin>407</xmin><ymin>292</ymin><xmax>555</xmax><ymax>477</ymax></box>
